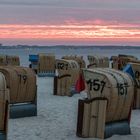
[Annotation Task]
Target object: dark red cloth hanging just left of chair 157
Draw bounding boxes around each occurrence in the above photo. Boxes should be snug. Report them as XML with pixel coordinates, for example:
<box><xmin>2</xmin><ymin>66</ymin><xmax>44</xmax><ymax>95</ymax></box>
<box><xmin>75</xmin><ymin>74</ymin><xmax>85</xmax><ymax>92</ymax></box>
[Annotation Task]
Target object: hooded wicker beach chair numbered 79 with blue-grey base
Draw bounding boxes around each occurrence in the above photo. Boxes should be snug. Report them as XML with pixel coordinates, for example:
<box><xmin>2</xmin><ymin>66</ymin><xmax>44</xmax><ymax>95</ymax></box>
<box><xmin>0</xmin><ymin>66</ymin><xmax>37</xmax><ymax>118</ymax></box>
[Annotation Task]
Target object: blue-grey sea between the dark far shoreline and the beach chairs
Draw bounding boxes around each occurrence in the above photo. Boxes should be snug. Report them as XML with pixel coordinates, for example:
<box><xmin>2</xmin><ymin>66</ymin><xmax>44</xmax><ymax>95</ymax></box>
<box><xmin>0</xmin><ymin>46</ymin><xmax>140</xmax><ymax>67</ymax></box>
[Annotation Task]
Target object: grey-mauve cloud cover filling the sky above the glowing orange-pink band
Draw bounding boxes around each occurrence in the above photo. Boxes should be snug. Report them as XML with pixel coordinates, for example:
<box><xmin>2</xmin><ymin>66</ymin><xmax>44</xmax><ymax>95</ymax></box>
<box><xmin>0</xmin><ymin>0</ymin><xmax>140</xmax><ymax>24</ymax></box>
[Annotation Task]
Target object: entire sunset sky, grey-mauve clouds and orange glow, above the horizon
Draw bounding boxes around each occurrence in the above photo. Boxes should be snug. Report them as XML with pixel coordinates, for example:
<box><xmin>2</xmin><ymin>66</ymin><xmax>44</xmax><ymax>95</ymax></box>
<box><xmin>0</xmin><ymin>0</ymin><xmax>140</xmax><ymax>45</ymax></box>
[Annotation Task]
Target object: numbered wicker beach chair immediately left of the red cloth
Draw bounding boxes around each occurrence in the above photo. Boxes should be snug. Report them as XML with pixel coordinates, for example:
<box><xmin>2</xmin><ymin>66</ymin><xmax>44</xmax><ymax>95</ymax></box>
<box><xmin>54</xmin><ymin>59</ymin><xmax>80</xmax><ymax>96</ymax></box>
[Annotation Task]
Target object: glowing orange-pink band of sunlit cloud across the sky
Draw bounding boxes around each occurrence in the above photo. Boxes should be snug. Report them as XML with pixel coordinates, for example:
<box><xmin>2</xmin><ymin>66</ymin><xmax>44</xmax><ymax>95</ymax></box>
<box><xmin>0</xmin><ymin>21</ymin><xmax>140</xmax><ymax>42</ymax></box>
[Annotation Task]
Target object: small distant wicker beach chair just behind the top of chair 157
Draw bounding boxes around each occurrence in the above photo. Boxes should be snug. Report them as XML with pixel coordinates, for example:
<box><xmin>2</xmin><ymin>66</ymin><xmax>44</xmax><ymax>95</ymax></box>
<box><xmin>87</xmin><ymin>55</ymin><xmax>109</xmax><ymax>68</ymax></box>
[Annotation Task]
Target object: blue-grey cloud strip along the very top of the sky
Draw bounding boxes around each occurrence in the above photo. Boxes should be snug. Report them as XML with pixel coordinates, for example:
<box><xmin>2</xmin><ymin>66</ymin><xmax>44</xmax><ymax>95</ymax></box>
<box><xmin>0</xmin><ymin>0</ymin><xmax>140</xmax><ymax>9</ymax></box>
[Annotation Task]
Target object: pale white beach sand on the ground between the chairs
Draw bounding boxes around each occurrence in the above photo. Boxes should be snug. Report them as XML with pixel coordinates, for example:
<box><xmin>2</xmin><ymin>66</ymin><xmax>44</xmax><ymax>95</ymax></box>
<box><xmin>8</xmin><ymin>77</ymin><xmax>140</xmax><ymax>140</ymax></box>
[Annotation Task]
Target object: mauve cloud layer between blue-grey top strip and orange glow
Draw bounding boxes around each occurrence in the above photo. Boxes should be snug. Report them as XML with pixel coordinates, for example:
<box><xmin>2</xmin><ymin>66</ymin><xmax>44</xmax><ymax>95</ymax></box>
<box><xmin>0</xmin><ymin>6</ymin><xmax>140</xmax><ymax>24</ymax></box>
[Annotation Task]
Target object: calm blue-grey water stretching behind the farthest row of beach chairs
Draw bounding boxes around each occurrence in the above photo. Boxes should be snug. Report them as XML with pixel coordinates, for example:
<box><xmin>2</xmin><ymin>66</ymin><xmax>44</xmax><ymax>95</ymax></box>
<box><xmin>0</xmin><ymin>47</ymin><xmax>140</xmax><ymax>66</ymax></box>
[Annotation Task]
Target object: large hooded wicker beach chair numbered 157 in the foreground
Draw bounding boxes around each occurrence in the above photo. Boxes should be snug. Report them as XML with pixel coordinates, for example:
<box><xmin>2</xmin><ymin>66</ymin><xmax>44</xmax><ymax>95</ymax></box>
<box><xmin>76</xmin><ymin>68</ymin><xmax>134</xmax><ymax>139</ymax></box>
